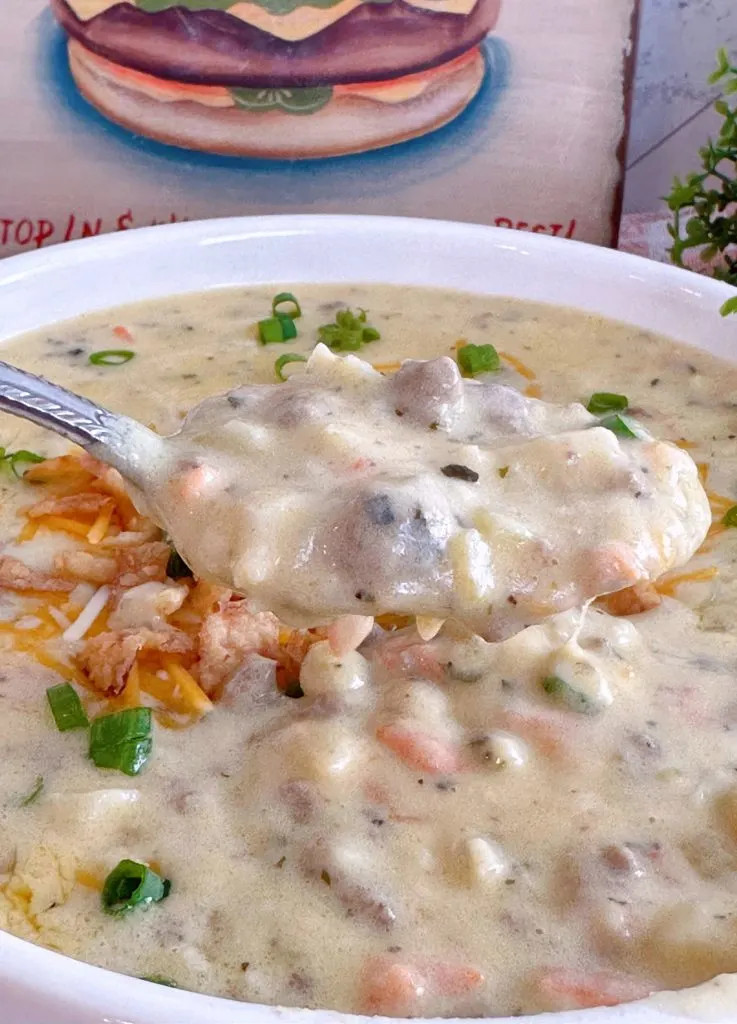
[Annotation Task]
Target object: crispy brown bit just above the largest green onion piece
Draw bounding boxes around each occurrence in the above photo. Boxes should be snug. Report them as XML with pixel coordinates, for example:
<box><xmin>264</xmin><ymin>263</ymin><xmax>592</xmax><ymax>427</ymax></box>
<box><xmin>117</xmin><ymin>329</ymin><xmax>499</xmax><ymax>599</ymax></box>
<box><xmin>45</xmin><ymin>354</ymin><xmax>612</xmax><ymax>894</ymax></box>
<box><xmin>76</xmin><ymin>629</ymin><xmax>194</xmax><ymax>696</ymax></box>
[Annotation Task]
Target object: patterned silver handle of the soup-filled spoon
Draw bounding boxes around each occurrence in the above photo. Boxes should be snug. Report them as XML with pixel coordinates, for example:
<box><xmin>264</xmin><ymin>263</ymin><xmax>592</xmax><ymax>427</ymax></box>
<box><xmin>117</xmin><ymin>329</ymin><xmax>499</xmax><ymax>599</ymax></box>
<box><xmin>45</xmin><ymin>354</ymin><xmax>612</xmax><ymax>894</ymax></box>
<box><xmin>0</xmin><ymin>360</ymin><xmax>162</xmax><ymax>483</ymax></box>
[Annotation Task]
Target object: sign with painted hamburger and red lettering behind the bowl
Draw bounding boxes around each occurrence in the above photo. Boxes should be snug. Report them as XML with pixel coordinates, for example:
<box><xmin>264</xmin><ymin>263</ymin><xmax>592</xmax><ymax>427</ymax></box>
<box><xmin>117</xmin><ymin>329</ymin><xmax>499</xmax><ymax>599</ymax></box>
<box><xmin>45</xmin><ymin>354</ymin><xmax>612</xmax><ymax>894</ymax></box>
<box><xmin>0</xmin><ymin>0</ymin><xmax>637</xmax><ymax>255</ymax></box>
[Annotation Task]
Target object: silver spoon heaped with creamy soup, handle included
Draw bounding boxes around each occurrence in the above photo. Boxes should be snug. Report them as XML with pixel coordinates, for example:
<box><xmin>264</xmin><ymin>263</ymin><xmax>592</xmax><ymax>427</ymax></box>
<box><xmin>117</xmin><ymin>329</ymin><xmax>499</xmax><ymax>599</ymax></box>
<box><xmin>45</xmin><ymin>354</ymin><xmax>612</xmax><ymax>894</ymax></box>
<box><xmin>0</xmin><ymin>345</ymin><xmax>710</xmax><ymax>640</ymax></box>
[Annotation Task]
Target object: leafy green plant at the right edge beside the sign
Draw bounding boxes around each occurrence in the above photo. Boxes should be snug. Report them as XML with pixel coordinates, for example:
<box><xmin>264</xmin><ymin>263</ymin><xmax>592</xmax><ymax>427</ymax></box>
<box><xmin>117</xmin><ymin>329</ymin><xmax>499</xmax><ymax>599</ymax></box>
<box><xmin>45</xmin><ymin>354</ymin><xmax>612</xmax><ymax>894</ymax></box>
<box><xmin>665</xmin><ymin>49</ymin><xmax>737</xmax><ymax>316</ymax></box>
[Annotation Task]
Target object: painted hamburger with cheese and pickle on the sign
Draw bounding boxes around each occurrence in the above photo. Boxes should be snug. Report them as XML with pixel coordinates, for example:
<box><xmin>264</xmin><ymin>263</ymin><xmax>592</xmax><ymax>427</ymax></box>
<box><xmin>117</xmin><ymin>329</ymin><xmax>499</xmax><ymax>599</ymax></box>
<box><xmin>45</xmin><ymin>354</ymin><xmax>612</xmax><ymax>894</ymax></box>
<box><xmin>51</xmin><ymin>0</ymin><xmax>502</xmax><ymax>160</ymax></box>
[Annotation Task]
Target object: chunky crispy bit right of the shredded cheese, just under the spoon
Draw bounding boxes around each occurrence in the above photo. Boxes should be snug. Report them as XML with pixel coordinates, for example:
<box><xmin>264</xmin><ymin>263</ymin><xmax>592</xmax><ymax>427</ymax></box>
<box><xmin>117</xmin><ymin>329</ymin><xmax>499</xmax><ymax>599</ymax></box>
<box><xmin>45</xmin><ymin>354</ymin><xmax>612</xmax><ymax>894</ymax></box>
<box><xmin>200</xmin><ymin>601</ymin><xmax>279</xmax><ymax>696</ymax></box>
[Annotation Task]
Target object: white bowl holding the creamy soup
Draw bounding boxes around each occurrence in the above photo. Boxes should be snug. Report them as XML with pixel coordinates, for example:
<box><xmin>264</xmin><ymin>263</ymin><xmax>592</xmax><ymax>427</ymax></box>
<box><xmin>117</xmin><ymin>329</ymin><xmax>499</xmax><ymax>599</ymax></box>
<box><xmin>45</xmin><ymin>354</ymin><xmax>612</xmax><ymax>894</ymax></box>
<box><xmin>0</xmin><ymin>216</ymin><xmax>737</xmax><ymax>1024</ymax></box>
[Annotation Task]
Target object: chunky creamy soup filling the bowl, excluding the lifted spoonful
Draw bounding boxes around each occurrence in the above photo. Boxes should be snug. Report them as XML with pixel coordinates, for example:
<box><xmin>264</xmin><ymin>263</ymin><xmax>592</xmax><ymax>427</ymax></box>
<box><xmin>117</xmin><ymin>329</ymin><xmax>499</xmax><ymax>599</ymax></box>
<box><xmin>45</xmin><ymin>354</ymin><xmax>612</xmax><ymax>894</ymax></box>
<box><xmin>0</xmin><ymin>286</ymin><xmax>737</xmax><ymax>1016</ymax></box>
